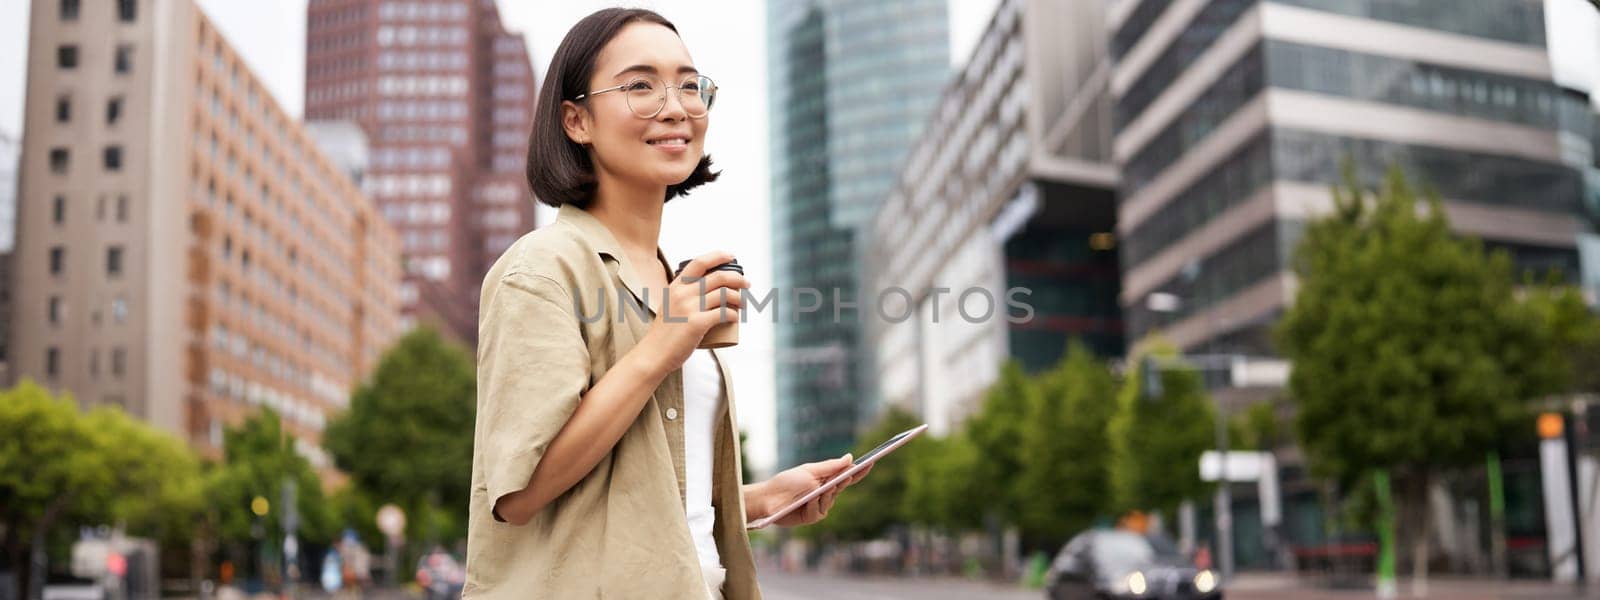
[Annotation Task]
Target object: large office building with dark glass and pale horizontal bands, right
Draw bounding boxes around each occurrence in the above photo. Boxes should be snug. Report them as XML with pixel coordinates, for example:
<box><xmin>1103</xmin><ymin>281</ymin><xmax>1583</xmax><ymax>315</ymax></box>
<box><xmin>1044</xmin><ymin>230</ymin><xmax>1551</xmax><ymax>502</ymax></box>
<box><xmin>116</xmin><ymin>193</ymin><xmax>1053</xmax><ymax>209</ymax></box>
<box><xmin>1107</xmin><ymin>0</ymin><xmax>1587</xmax><ymax>355</ymax></box>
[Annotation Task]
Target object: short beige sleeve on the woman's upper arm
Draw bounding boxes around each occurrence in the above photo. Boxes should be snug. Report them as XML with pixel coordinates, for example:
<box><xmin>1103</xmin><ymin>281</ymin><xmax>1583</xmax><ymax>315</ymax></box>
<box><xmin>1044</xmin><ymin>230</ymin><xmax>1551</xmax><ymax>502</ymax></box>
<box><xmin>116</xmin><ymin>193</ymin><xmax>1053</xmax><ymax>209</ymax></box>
<box><xmin>477</xmin><ymin>274</ymin><xmax>601</xmax><ymax>522</ymax></box>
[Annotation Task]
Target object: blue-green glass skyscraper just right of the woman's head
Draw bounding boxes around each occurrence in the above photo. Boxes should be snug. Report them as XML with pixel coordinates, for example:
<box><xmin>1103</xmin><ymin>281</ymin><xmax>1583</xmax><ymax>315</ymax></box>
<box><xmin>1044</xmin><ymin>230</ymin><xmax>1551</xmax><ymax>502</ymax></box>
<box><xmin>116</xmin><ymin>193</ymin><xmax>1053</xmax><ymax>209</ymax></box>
<box><xmin>766</xmin><ymin>0</ymin><xmax>949</xmax><ymax>466</ymax></box>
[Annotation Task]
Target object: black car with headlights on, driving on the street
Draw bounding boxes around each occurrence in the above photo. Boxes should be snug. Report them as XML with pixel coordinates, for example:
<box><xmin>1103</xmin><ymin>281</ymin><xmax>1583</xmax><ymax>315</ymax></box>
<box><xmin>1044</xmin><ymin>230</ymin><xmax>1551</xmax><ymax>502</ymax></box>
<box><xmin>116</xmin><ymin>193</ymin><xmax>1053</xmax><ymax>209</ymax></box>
<box><xmin>1045</xmin><ymin>530</ymin><xmax>1222</xmax><ymax>600</ymax></box>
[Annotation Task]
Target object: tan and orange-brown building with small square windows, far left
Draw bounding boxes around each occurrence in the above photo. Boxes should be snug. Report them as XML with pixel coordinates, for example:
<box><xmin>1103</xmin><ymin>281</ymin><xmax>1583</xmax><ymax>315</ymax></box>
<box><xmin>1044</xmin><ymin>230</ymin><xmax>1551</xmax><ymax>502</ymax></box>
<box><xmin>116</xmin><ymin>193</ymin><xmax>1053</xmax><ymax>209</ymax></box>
<box><xmin>8</xmin><ymin>0</ymin><xmax>400</xmax><ymax>467</ymax></box>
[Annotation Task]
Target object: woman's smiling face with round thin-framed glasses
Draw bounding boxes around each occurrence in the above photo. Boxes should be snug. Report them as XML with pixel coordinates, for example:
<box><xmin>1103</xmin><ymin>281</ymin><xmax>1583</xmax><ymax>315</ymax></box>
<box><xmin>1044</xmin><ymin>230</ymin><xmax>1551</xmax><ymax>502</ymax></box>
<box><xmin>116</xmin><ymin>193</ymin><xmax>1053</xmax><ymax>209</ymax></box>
<box><xmin>562</xmin><ymin>22</ymin><xmax>707</xmax><ymax>193</ymax></box>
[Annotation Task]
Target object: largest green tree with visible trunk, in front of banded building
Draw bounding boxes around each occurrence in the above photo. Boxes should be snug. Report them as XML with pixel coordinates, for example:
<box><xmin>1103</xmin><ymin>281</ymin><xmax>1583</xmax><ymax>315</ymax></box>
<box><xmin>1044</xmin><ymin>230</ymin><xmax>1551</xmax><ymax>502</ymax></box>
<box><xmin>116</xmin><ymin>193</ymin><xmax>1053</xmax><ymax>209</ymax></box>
<box><xmin>1277</xmin><ymin>170</ymin><xmax>1560</xmax><ymax>581</ymax></box>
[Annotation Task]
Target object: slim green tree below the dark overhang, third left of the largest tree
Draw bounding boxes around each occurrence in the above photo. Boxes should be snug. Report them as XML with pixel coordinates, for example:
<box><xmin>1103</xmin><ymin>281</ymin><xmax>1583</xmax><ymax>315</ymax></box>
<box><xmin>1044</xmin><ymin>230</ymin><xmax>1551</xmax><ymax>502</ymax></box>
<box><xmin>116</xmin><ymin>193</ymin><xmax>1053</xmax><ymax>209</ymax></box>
<box><xmin>966</xmin><ymin>360</ymin><xmax>1038</xmax><ymax>525</ymax></box>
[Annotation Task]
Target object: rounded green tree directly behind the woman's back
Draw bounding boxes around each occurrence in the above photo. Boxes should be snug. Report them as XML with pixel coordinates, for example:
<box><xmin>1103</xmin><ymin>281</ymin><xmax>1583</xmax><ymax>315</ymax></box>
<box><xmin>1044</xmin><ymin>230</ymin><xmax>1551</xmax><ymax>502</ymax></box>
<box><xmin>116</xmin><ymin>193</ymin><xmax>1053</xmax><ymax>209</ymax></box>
<box><xmin>323</xmin><ymin>328</ymin><xmax>477</xmax><ymax>541</ymax></box>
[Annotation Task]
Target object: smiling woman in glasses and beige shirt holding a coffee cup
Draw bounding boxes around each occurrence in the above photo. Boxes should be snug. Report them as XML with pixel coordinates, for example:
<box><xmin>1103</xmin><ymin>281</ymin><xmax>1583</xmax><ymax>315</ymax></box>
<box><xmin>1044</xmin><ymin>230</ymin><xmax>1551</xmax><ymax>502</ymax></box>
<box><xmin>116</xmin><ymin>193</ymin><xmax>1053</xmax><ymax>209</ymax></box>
<box><xmin>464</xmin><ymin>8</ymin><xmax>866</xmax><ymax>600</ymax></box>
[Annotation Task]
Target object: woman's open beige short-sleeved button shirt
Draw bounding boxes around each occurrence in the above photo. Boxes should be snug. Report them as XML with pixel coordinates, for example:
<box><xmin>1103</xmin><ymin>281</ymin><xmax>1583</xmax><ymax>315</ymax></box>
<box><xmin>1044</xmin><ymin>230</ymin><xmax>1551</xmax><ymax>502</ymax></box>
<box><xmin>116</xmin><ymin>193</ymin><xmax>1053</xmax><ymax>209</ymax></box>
<box><xmin>464</xmin><ymin>206</ymin><xmax>762</xmax><ymax>600</ymax></box>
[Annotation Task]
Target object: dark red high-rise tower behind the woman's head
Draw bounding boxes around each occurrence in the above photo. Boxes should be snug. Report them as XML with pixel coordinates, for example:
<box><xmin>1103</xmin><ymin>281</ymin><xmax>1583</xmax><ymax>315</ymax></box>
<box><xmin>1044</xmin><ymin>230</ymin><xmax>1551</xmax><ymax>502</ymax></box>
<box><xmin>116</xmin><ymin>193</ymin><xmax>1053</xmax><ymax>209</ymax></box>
<box><xmin>306</xmin><ymin>0</ymin><xmax>534</xmax><ymax>344</ymax></box>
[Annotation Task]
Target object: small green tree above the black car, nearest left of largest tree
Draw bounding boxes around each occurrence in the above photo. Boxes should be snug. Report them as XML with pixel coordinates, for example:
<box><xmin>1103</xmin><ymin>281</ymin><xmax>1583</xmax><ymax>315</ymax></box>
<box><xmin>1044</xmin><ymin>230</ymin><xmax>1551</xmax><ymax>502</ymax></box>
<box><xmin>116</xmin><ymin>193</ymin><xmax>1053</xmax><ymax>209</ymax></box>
<box><xmin>1112</xmin><ymin>347</ymin><xmax>1216</xmax><ymax>515</ymax></box>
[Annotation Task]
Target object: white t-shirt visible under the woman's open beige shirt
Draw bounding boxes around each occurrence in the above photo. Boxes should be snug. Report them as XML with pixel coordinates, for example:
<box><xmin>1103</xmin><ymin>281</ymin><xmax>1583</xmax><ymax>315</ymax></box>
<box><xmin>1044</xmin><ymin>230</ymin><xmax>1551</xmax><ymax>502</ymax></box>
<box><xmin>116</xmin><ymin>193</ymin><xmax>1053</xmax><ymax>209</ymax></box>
<box><xmin>683</xmin><ymin>349</ymin><xmax>722</xmax><ymax>568</ymax></box>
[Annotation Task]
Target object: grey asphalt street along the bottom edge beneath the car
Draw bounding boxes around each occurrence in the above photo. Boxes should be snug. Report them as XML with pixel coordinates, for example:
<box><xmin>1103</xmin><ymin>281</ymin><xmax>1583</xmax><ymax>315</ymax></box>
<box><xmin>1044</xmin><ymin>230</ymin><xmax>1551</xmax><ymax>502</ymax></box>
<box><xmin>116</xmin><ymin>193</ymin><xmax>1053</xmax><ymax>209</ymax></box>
<box><xmin>760</xmin><ymin>568</ymin><xmax>1600</xmax><ymax>600</ymax></box>
